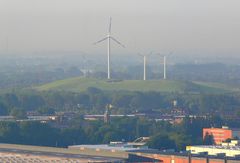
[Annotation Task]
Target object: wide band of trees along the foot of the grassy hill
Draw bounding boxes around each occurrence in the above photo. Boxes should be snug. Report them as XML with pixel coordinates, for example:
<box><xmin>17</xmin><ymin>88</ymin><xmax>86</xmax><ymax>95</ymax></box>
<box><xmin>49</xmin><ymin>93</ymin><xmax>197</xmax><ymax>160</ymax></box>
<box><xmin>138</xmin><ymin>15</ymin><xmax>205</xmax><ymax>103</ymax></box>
<box><xmin>0</xmin><ymin>88</ymin><xmax>240</xmax><ymax>116</ymax></box>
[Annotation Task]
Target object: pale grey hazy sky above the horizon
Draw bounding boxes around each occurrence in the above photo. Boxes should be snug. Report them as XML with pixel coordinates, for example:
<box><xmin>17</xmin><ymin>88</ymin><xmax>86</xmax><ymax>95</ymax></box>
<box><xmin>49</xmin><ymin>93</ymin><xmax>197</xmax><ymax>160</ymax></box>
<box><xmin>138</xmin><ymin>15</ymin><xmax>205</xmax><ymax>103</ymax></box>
<box><xmin>0</xmin><ymin>0</ymin><xmax>240</xmax><ymax>56</ymax></box>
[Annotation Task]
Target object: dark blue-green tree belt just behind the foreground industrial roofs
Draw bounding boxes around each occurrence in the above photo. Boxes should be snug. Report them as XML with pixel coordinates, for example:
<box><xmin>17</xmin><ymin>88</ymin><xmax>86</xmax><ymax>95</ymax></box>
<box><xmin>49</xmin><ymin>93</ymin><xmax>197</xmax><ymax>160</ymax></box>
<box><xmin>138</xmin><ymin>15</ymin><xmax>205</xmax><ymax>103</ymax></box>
<box><xmin>0</xmin><ymin>118</ymin><xmax>228</xmax><ymax>150</ymax></box>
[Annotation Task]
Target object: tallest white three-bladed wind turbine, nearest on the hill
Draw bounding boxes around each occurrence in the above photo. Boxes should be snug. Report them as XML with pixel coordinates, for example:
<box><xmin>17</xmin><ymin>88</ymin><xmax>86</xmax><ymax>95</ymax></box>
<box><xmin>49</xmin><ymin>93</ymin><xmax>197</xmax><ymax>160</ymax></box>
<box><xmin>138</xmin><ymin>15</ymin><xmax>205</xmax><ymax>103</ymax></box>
<box><xmin>94</xmin><ymin>17</ymin><xmax>125</xmax><ymax>79</ymax></box>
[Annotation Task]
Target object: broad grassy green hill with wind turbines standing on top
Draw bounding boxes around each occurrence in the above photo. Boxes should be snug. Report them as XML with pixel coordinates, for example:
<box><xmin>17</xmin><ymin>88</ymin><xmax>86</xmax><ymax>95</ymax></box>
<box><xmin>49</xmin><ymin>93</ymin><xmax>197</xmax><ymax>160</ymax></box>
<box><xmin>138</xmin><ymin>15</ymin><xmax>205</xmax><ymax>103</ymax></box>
<box><xmin>36</xmin><ymin>77</ymin><xmax>238</xmax><ymax>93</ymax></box>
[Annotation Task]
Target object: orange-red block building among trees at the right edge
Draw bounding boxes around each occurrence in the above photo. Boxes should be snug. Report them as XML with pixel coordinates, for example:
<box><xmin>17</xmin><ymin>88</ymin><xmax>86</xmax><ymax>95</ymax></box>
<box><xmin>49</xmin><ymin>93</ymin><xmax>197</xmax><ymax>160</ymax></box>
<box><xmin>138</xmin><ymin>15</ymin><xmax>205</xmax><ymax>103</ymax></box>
<box><xmin>203</xmin><ymin>126</ymin><xmax>240</xmax><ymax>145</ymax></box>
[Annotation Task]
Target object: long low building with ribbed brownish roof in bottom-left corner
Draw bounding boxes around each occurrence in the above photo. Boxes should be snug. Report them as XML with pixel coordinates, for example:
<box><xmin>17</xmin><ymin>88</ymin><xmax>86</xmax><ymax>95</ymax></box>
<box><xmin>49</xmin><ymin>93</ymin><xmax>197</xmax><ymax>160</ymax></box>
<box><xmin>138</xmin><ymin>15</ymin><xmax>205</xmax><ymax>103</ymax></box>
<box><xmin>0</xmin><ymin>144</ymin><xmax>123</xmax><ymax>163</ymax></box>
